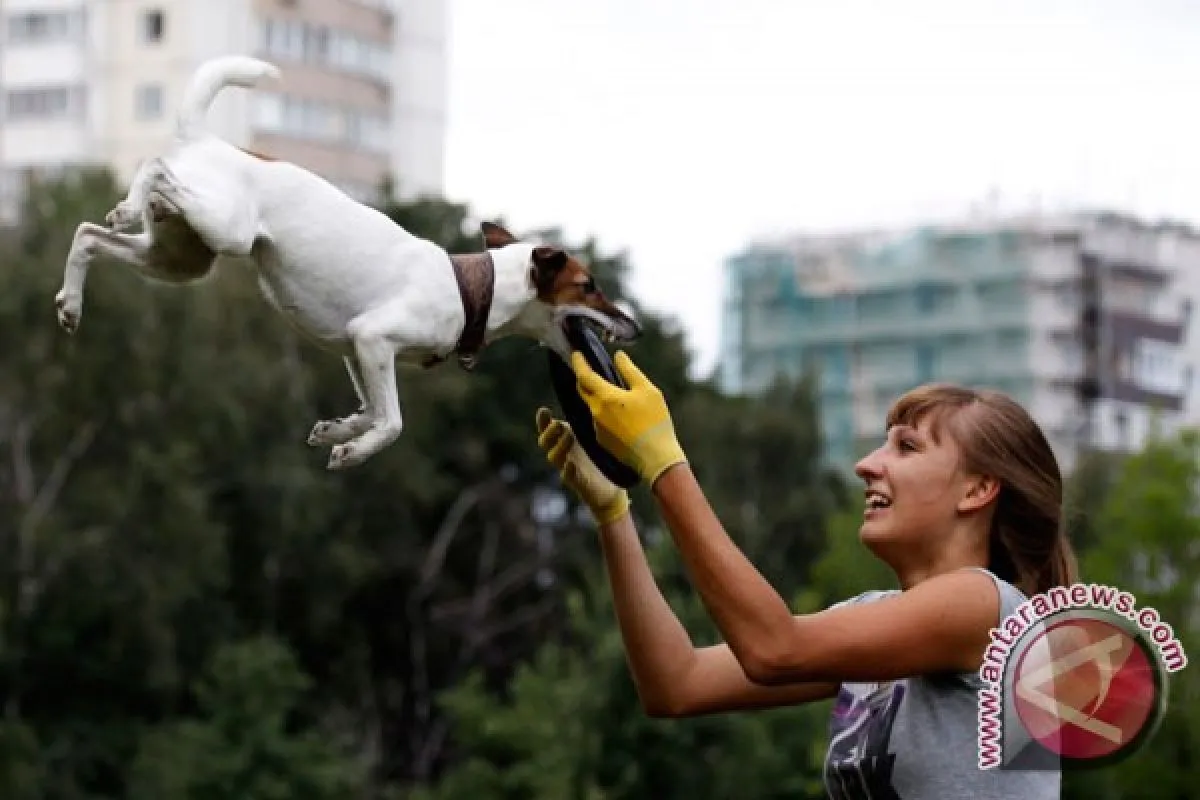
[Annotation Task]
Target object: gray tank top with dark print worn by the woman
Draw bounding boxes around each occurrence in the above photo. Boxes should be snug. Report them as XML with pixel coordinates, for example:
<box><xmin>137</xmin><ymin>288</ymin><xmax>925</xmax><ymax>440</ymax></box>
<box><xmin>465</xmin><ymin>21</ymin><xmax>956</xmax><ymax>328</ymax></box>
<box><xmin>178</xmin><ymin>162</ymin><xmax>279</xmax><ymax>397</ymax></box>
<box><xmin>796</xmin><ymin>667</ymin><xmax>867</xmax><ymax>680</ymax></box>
<box><xmin>824</xmin><ymin>571</ymin><xmax>1061</xmax><ymax>800</ymax></box>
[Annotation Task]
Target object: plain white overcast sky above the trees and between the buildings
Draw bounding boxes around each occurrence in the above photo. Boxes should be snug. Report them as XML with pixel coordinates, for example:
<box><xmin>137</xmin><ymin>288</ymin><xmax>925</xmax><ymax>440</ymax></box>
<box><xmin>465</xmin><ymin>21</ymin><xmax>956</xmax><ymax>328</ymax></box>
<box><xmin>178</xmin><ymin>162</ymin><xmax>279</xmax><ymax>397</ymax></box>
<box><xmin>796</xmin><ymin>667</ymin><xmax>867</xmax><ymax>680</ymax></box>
<box><xmin>446</xmin><ymin>0</ymin><xmax>1200</xmax><ymax>377</ymax></box>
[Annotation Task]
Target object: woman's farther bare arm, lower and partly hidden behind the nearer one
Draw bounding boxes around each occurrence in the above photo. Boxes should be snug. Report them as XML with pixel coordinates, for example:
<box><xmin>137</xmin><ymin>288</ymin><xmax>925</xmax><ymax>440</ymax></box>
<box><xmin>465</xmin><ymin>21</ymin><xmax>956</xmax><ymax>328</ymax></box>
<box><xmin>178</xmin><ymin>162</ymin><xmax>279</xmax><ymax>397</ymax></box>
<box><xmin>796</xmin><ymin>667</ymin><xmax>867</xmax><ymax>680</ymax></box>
<box><xmin>600</xmin><ymin>513</ymin><xmax>838</xmax><ymax>717</ymax></box>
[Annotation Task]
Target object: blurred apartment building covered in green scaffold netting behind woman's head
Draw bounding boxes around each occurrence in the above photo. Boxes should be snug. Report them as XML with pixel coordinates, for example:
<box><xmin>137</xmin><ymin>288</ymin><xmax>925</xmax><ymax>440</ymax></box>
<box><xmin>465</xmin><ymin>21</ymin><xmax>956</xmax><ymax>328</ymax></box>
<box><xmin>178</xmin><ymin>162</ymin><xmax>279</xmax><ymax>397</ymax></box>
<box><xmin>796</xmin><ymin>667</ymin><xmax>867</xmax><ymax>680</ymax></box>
<box><xmin>720</xmin><ymin>213</ymin><xmax>1200</xmax><ymax>470</ymax></box>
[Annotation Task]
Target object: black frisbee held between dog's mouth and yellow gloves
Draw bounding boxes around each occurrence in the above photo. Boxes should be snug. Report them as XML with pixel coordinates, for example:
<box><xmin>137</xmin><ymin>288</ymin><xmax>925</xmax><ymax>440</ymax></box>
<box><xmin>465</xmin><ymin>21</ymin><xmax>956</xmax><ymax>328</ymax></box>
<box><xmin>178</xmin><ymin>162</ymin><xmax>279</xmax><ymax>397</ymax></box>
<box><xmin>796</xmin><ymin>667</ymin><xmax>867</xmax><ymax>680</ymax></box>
<box><xmin>546</xmin><ymin>317</ymin><xmax>640</xmax><ymax>489</ymax></box>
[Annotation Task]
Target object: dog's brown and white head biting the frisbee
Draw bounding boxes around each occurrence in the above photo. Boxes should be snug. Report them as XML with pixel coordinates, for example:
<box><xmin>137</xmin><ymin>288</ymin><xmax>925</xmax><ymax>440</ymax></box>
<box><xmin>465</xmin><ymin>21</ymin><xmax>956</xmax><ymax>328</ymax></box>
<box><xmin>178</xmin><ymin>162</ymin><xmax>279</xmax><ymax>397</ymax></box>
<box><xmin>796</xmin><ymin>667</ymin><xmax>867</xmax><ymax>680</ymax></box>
<box><xmin>482</xmin><ymin>222</ymin><xmax>642</xmax><ymax>359</ymax></box>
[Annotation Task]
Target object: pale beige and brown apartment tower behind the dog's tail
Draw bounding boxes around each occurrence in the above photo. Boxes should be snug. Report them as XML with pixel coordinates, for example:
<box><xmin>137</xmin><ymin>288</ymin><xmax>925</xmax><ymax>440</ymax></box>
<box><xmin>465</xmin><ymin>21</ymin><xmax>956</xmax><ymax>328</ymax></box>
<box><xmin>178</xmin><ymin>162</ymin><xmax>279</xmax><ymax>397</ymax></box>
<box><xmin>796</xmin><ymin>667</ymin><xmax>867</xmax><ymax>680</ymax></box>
<box><xmin>0</xmin><ymin>0</ymin><xmax>448</xmax><ymax>218</ymax></box>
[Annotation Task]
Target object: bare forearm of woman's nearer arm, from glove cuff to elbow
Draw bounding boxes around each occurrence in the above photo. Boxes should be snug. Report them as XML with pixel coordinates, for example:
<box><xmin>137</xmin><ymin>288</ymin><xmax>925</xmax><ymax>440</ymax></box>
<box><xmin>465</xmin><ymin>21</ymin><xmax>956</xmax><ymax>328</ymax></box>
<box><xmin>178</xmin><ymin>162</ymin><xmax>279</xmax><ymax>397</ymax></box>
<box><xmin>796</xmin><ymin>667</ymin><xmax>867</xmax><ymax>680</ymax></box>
<box><xmin>654</xmin><ymin>463</ymin><xmax>796</xmax><ymax>678</ymax></box>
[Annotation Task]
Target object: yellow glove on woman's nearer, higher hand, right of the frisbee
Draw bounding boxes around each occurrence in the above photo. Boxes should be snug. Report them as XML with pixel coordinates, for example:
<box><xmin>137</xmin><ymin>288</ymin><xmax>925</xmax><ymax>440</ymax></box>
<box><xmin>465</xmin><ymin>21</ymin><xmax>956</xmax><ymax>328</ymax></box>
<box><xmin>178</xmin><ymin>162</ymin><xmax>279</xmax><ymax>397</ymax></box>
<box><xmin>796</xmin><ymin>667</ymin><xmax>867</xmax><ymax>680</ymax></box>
<box><xmin>571</xmin><ymin>350</ymin><xmax>688</xmax><ymax>487</ymax></box>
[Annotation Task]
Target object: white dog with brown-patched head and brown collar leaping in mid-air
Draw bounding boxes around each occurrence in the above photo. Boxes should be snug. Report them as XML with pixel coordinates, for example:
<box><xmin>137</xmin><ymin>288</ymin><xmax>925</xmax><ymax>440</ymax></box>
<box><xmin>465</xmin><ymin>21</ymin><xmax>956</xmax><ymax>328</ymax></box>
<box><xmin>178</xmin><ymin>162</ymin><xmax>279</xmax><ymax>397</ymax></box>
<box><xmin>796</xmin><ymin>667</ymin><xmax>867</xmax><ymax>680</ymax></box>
<box><xmin>55</xmin><ymin>56</ymin><xmax>640</xmax><ymax>469</ymax></box>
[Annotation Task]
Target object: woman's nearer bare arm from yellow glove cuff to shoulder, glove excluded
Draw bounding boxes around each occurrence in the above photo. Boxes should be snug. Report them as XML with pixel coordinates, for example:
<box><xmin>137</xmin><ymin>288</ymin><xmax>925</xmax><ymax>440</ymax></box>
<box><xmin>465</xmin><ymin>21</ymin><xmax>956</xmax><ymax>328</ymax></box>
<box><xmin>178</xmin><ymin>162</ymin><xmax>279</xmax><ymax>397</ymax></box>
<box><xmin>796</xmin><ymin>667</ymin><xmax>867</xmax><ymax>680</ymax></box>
<box><xmin>653</xmin><ymin>462</ymin><xmax>1000</xmax><ymax>685</ymax></box>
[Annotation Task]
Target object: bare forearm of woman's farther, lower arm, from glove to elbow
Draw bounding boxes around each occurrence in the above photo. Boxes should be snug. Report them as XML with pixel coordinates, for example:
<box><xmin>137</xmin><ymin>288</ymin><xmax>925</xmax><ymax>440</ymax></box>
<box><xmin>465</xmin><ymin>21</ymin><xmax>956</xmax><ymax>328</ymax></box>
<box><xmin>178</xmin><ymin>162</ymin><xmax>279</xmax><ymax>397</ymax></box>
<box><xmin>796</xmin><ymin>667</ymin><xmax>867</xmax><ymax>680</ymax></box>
<box><xmin>600</xmin><ymin>513</ymin><xmax>696</xmax><ymax>712</ymax></box>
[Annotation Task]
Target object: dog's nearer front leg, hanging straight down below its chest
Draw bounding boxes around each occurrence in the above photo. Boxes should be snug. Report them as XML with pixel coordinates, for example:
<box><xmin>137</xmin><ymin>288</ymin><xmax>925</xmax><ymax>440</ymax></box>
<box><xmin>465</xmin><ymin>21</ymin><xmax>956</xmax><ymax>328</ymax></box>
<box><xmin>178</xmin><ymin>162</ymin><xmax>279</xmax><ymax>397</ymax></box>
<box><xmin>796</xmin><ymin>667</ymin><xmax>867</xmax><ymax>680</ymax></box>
<box><xmin>329</xmin><ymin>306</ymin><xmax>403</xmax><ymax>469</ymax></box>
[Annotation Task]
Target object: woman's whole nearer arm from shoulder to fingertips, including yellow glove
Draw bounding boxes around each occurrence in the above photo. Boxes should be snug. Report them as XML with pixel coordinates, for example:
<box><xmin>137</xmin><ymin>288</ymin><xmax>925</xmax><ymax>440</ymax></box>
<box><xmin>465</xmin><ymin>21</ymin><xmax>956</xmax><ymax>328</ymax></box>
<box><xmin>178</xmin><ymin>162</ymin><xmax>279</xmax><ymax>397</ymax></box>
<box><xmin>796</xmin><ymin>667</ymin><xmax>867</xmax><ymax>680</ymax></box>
<box><xmin>571</xmin><ymin>351</ymin><xmax>1000</xmax><ymax>685</ymax></box>
